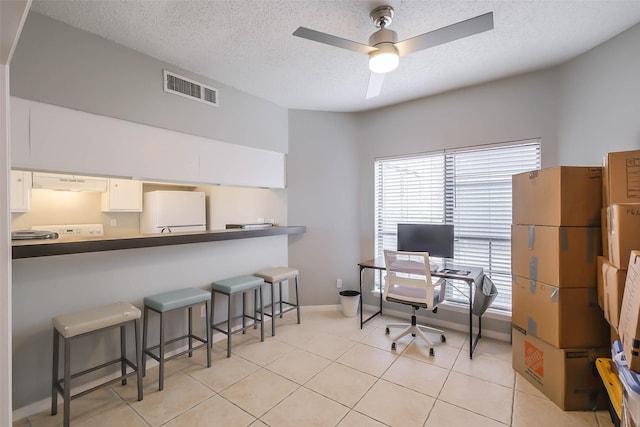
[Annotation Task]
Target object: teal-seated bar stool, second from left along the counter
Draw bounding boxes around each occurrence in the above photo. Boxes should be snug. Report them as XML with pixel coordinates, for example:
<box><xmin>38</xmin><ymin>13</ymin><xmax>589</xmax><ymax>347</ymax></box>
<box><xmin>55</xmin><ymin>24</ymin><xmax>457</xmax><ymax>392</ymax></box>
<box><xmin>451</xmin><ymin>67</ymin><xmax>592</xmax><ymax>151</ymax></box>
<box><xmin>142</xmin><ymin>288</ymin><xmax>211</xmax><ymax>391</ymax></box>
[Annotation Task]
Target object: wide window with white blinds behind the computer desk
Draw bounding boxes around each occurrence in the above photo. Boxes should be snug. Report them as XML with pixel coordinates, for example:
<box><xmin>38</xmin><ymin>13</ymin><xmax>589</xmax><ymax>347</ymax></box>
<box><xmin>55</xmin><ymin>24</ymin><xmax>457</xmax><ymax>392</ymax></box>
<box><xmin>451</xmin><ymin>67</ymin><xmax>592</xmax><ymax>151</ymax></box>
<box><xmin>375</xmin><ymin>140</ymin><xmax>540</xmax><ymax>311</ymax></box>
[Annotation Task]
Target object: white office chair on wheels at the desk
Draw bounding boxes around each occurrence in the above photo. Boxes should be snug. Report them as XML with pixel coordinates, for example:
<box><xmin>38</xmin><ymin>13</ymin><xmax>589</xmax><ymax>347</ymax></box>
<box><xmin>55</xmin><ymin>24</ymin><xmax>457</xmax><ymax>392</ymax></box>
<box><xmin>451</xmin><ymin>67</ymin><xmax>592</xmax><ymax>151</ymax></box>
<box><xmin>383</xmin><ymin>250</ymin><xmax>447</xmax><ymax>356</ymax></box>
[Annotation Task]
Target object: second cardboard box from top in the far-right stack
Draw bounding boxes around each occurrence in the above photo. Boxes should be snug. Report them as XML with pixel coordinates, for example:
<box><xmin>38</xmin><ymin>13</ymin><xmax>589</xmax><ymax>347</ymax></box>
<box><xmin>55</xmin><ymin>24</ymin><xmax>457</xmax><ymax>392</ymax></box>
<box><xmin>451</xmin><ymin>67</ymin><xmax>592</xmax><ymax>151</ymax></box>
<box><xmin>607</xmin><ymin>203</ymin><xmax>640</xmax><ymax>270</ymax></box>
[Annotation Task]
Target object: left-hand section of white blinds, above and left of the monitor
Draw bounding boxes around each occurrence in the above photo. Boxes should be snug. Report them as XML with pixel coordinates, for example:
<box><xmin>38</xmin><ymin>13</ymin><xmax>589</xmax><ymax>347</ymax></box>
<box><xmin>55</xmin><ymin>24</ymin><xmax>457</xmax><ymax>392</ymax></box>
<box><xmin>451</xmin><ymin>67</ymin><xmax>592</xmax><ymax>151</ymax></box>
<box><xmin>375</xmin><ymin>153</ymin><xmax>445</xmax><ymax>257</ymax></box>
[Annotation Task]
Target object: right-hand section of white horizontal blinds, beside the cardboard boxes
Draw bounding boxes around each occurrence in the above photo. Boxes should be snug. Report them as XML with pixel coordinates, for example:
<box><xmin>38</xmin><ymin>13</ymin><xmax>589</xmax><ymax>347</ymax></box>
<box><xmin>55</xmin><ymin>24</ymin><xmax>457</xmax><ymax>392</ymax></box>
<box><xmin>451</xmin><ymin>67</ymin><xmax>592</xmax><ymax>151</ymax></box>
<box><xmin>445</xmin><ymin>141</ymin><xmax>540</xmax><ymax>310</ymax></box>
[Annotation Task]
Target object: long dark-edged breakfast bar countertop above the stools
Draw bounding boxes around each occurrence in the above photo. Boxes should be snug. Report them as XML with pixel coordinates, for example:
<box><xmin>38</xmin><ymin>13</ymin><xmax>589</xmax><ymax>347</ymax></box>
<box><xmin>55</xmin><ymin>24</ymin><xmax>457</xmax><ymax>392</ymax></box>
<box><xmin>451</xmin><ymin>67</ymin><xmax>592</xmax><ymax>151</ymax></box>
<box><xmin>11</xmin><ymin>226</ymin><xmax>306</xmax><ymax>259</ymax></box>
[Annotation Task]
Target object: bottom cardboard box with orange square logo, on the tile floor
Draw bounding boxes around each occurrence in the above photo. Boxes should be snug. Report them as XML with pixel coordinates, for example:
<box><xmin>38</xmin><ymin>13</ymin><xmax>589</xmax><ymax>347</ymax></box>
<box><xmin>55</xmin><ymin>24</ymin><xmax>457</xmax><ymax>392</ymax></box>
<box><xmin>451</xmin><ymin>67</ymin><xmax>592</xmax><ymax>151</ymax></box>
<box><xmin>511</xmin><ymin>328</ymin><xmax>611</xmax><ymax>411</ymax></box>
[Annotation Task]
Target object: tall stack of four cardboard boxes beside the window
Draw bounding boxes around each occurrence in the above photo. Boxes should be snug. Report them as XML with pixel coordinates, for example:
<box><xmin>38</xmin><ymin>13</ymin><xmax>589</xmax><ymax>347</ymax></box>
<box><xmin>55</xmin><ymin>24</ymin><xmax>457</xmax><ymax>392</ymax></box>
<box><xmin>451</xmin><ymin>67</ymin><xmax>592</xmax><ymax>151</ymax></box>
<box><xmin>511</xmin><ymin>166</ymin><xmax>611</xmax><ymax>410</ymax></box>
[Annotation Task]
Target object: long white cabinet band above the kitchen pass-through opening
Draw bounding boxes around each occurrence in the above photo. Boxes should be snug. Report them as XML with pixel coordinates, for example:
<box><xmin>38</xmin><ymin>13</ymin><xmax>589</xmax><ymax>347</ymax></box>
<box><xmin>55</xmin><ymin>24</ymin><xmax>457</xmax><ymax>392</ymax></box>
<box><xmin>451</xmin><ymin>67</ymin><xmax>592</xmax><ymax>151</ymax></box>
<box><xmin>12</xmin><ymin>98</ymin><xmax>285</xmax><ymax>188</ymax></box>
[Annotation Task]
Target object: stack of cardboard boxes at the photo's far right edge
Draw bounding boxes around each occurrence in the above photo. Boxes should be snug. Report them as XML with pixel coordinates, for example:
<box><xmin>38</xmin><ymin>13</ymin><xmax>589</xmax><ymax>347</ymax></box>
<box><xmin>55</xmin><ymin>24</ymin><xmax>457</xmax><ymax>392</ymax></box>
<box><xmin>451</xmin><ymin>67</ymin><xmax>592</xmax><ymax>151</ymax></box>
<box><xmin>599</xmin><ymin>150</ymin><xmax>640</xmax><ymax>331</ymax></box>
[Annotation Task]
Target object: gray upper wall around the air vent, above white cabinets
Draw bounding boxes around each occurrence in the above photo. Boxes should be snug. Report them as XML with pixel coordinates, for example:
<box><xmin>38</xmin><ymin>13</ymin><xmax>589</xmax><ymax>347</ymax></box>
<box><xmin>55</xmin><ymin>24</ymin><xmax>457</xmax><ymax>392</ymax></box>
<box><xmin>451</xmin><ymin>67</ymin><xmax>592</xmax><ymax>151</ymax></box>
<box><xmin>11</xmin><ymin>12</ymin><xmax>288</xmax><ymax>153</ymax></box>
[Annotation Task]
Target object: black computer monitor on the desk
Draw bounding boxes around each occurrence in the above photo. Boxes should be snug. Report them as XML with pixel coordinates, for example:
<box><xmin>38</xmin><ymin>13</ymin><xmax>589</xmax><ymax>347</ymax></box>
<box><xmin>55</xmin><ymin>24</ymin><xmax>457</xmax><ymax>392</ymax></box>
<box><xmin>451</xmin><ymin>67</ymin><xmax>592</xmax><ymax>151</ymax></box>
<box><xmin>398</xmin><ymin>224</ymin><xmax>453</xmax><ymax>258</ymax></box>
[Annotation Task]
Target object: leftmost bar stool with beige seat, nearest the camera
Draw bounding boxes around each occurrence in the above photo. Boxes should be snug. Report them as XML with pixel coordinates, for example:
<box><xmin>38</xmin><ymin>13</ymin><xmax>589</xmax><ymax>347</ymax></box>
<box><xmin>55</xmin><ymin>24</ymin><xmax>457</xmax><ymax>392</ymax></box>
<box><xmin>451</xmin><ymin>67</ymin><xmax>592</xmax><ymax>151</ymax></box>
<box><xmin>51</xmin><ymin>302</ymin><xmax>142</xmax><ymax>427</ymax></box>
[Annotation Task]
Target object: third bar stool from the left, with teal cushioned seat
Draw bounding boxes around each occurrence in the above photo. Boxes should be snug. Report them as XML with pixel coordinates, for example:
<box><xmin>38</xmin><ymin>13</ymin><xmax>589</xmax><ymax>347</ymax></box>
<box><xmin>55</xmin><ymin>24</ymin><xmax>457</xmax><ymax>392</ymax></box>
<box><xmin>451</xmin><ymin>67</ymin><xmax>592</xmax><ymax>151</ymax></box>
<box><xmin>211</xmin><ymin>276</ymin><xmax>264</xmax><ymax>357</ymax></box>
